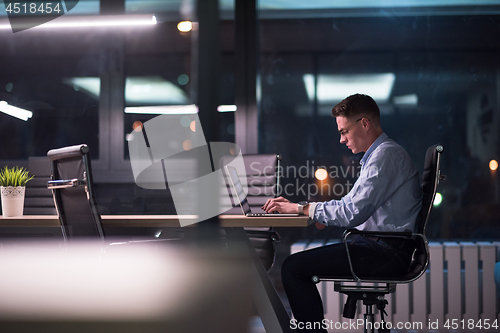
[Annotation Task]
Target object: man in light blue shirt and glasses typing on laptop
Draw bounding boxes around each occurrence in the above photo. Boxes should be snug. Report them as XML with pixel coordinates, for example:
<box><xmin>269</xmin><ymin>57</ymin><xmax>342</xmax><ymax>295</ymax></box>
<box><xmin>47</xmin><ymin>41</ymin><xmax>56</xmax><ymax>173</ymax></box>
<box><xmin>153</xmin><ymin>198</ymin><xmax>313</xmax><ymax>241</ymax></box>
<box><xmin>262</xmin><ymin>94</ymin><xmax>422</xmax><ymax>332</ymax></box>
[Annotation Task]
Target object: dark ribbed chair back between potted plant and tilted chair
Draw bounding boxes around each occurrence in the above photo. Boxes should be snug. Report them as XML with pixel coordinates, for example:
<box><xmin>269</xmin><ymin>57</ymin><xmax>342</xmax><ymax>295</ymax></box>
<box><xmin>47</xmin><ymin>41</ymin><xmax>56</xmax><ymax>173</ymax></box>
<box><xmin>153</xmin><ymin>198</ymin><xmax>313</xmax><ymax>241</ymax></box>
<box><xmin>24</xmin><ymin>156</ymin><xmax>57</xmax><ymax>215</ymax></box>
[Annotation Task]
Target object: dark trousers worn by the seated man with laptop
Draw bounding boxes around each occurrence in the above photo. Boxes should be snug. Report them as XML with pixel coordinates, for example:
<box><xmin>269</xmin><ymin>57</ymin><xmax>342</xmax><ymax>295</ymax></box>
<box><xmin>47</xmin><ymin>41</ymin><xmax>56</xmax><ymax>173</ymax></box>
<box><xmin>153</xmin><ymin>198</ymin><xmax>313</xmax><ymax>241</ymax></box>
<box><xmin>281</xmin><ymin>235</ymin><xmax>413</xmax><ymax>332</ymax></box>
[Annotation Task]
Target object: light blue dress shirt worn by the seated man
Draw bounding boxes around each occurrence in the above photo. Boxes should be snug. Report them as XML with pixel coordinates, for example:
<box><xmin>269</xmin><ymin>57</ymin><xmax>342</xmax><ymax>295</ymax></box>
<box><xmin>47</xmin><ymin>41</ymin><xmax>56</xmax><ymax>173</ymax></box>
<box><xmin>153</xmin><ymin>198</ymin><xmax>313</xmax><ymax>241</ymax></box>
<box><xmin>309</xmin><ymin>133</ymin><xmax>422</xmax><ymax>232</ymax></box>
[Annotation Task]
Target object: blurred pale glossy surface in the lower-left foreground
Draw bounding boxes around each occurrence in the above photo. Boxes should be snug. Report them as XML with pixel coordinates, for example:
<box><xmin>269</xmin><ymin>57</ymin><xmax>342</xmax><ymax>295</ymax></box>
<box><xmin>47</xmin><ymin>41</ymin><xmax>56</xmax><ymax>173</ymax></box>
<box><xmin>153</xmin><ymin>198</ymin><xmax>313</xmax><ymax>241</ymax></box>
<box><xmin>0</xmin><ymin>241</ymin><xmax>252</xmax><ymax>333</ymax></box>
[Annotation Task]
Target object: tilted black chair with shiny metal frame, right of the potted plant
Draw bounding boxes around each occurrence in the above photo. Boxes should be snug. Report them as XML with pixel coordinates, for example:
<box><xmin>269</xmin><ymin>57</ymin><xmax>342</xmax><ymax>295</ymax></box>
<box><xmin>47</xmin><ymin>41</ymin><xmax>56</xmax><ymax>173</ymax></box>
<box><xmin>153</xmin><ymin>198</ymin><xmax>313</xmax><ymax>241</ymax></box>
<box><xmin>47</xmin><ymin>144</ymin><xmax>104</xmax><ymax>240</ymax></box>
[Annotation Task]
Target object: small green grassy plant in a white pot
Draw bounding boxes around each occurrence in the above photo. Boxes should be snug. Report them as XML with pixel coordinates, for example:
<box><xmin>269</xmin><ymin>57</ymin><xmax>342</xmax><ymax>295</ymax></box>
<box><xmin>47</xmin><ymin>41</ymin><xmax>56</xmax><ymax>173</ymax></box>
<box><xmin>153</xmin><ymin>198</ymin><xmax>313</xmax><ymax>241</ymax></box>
<box><xmin>0</xmin><ymin>166</ymin><xmax>34</xmax><ymax>217</ymax></box>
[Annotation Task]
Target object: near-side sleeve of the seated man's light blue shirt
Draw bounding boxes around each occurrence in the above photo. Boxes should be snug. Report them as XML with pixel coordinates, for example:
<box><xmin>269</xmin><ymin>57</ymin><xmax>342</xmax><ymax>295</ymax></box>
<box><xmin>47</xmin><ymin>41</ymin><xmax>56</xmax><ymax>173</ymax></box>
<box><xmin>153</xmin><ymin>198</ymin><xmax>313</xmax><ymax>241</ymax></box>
<box><xmin>311</xmin><ymin>147</ymin><xmax>405</xmax><ymax>227</ymax></box>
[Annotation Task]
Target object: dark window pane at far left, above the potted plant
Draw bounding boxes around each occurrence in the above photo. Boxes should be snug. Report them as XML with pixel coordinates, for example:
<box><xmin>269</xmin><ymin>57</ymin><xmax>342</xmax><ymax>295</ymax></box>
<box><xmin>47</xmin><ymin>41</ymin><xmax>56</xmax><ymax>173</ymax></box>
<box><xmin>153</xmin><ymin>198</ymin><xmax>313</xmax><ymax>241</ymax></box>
<box><xmin>0</xmin><ymin>52</ymin><xmax>100</xmax><ymax>160</ymax></box>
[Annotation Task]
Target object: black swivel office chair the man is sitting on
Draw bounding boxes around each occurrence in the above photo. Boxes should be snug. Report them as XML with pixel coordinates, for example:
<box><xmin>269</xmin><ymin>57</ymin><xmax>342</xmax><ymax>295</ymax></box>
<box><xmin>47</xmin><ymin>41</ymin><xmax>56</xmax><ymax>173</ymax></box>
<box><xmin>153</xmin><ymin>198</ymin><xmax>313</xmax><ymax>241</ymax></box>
<box><xmin>312</xmin><ymin>145</ymin><xmax>446</xmax><ymax>332</ymax></box>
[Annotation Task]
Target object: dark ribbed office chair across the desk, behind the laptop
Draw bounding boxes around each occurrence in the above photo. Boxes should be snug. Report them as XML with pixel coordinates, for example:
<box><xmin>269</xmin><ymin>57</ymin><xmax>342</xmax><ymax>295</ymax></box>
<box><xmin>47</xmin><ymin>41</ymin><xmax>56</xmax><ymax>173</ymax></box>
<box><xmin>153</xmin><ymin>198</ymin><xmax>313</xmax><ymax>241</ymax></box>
<box><xmin>221</xmin><ymin>154</ymin><xmax>281</xmax><ymax>272</ymax></box>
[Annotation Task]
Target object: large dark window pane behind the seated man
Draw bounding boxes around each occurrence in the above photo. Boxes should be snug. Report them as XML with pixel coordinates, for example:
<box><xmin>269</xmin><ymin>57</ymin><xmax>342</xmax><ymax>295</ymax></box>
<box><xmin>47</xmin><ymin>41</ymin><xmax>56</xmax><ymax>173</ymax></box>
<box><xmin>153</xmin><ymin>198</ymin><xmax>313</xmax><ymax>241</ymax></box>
<box><xmin>259</xmin><ymin>0</ymin><xmax>500</xmax><ymax>240</ymax></box>
